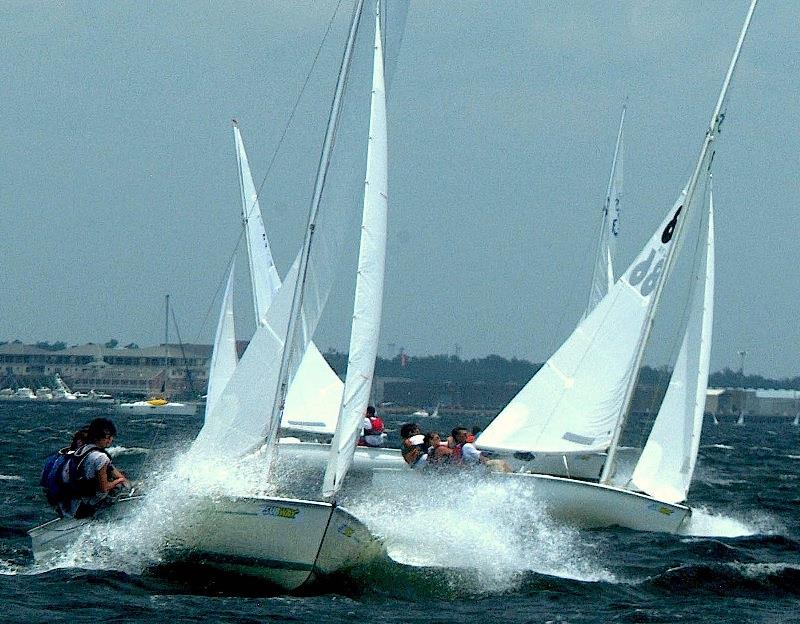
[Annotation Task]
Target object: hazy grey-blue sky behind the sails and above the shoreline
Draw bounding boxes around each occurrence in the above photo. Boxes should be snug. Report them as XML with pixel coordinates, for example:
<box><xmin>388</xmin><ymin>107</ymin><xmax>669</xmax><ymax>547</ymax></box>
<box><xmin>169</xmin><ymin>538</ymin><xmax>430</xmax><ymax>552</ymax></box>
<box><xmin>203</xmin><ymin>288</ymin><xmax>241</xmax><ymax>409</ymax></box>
<box><xmin>0</xmin><ymin>0</ymin><xmax>800</xmax><ymax>376</ymax></box>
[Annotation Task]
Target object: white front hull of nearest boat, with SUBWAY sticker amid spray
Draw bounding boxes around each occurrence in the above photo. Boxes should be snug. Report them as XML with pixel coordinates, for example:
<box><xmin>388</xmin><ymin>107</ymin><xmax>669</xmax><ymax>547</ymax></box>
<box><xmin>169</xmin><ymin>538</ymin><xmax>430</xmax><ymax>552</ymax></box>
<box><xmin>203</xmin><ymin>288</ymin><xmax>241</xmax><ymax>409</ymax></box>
<box><xmin>168</xmin><ymin>497</ymin><xmax>383</xmax><ymax>591</ymax></box>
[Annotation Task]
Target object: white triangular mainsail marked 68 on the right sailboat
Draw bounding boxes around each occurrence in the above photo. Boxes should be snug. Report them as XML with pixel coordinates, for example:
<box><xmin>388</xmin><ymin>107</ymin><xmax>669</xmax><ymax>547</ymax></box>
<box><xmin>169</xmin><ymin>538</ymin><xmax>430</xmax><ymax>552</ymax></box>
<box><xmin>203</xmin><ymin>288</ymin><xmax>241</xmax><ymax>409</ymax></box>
<box><xmin>477</xmin><ymin>191</ymin><xmax>685</xmax><ymax>454</ymax></box>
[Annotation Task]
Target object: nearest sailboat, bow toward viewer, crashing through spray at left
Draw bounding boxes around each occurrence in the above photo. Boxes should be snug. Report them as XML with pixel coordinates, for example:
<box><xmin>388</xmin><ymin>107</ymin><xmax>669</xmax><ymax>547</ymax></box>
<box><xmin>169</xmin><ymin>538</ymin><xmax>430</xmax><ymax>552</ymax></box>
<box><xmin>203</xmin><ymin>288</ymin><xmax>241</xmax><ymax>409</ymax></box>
<box><xmin>162</xmin><ymin>0</ymin><xmax>388</xmax><ymax>590</ymax></box>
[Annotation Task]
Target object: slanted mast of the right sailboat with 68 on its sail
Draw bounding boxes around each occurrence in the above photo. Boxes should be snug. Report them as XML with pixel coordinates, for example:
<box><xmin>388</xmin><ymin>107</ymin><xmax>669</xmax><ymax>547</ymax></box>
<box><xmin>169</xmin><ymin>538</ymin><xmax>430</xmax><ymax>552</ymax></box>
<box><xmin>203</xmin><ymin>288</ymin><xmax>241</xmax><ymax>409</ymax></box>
<box><xmin>600</xmin><ymin>0</ymin><xmax>758</xmax><ymax>484</ymax></box>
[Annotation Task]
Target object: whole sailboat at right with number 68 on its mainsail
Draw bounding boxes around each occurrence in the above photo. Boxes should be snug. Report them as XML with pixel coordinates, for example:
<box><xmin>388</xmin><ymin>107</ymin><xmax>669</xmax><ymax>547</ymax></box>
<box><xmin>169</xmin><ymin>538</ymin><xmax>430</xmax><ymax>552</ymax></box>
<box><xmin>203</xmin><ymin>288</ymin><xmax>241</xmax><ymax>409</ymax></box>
<box><xmin>476</xmin><ymin>0</ymin><xmax>757</xmax><ymax>532</ymax></box>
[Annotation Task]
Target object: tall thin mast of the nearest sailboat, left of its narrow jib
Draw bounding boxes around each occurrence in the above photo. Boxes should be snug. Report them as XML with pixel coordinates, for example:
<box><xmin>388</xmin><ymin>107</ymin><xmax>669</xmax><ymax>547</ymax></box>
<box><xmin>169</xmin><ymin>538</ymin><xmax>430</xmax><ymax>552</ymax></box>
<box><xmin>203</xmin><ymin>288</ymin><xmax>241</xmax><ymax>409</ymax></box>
<box><xmin>266</xmin><ymin>0</ymin><xmax>364</xmax><ymax>472</ymax></box>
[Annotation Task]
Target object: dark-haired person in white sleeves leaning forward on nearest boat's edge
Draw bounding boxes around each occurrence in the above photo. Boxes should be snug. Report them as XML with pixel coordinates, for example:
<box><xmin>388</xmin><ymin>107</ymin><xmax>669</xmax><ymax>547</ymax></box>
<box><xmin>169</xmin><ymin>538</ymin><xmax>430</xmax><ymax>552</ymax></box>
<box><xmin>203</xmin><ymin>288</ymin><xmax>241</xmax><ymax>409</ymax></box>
<box><xmin>63</xmin><ymin>418</ymin><xmax>129</xmax><ymax>519</ymax></box>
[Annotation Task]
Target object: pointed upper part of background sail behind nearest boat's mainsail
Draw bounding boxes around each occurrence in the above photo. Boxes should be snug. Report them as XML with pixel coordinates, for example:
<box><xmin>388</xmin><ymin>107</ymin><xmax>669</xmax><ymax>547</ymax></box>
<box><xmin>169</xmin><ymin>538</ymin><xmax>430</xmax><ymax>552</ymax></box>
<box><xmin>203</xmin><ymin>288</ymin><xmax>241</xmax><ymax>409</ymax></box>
<box><xmin>233</xmin><ymin>121</ymin><xmax>281</xmax><ymax>325</ymax></box>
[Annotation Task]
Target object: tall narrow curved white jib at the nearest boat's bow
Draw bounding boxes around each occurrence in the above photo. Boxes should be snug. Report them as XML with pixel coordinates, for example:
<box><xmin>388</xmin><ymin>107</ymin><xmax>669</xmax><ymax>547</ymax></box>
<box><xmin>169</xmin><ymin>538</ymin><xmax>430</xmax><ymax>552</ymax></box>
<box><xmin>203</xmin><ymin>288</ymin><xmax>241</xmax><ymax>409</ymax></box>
<box><xmin>322</xmin><ymin>1</ymin><xmax>389</xmax><ymax>498</ymax></box>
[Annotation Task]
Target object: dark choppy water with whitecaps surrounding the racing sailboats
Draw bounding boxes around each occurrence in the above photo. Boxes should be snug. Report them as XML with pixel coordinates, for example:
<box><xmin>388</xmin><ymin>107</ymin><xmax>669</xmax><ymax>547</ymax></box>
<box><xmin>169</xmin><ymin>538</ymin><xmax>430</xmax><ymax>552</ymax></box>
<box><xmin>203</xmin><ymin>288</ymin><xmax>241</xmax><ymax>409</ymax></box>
<box><xmin>0</xmin><ymin>404</ymin><xmax>800</xmax><ymax>624</ymax></box>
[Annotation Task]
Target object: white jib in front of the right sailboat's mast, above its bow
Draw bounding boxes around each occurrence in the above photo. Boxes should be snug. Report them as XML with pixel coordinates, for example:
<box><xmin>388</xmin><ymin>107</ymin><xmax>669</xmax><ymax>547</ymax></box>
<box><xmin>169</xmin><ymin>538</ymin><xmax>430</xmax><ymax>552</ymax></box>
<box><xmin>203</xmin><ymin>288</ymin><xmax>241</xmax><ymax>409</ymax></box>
<box><xmin>631</xmin><ymin>180</ymin><xmax>714</xmax><ymax>503</ymax></box>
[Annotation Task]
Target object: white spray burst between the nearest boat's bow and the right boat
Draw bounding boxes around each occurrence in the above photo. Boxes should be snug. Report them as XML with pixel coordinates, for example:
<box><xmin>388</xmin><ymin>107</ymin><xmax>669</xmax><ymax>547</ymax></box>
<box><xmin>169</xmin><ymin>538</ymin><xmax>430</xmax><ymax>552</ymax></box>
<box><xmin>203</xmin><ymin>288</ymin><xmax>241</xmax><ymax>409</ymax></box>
<box><xmin>343</xmin><ymin>473</ymin><xmax>616</xmax><ymax>592</ymax></box>
